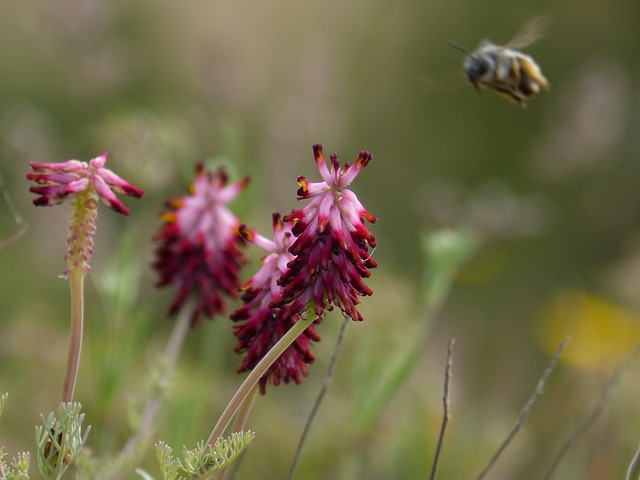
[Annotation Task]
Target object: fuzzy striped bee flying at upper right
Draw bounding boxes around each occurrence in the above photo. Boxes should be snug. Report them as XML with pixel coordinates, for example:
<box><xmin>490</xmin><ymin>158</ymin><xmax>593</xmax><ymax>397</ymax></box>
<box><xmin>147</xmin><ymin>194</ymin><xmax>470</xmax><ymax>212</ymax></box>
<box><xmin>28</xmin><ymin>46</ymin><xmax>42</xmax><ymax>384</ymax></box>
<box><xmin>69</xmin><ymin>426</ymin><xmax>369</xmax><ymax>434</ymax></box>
<box><xmin>451</xmin><ymin>18</ymin><xmax>550</xmax><ymax>108</ymax></box>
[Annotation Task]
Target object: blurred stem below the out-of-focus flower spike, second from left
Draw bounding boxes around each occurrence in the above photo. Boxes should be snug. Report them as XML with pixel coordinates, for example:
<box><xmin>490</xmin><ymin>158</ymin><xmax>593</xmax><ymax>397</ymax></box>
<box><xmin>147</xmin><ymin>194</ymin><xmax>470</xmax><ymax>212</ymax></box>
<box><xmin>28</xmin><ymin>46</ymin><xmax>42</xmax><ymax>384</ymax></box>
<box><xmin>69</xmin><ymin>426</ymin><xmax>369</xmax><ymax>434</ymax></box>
<box><xmin>119</xmin><ymin>308</ymin><xmax>191</xmax><ymax>457</ymax></box>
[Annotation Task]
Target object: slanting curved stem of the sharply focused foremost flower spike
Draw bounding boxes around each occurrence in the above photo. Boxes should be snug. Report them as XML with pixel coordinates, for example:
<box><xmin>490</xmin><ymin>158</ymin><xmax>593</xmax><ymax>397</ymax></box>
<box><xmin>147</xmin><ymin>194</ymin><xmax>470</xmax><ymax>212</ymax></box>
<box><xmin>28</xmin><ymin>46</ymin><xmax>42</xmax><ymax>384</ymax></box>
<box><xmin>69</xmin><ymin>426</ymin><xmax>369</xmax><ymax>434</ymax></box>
<box><xmin>207</xmin><ymin>318</ymin><xmax>313</xmax><ymax>445</ymax></box>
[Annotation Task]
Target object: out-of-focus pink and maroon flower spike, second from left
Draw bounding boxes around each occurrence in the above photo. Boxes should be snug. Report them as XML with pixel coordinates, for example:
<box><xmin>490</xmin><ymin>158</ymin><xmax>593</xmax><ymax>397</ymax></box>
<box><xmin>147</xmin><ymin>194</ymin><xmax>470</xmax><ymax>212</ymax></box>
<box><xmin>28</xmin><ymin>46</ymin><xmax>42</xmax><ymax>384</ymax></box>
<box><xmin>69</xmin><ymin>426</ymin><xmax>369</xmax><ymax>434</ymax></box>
<box><xmin>153</xmin><ymin>163</ymin><xmax>249</xmax><ymax>327</ymax></box>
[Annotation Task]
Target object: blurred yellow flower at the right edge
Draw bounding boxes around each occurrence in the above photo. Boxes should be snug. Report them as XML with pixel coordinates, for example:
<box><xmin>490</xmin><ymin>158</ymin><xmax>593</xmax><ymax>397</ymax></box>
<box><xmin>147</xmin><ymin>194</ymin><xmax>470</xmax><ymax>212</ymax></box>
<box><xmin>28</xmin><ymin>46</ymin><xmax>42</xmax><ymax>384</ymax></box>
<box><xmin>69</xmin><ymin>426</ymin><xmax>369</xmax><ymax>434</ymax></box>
<box><xmin>537</xmin><ymin>291</ymin><xmax>640</xmax><ymax>370</ymax></box>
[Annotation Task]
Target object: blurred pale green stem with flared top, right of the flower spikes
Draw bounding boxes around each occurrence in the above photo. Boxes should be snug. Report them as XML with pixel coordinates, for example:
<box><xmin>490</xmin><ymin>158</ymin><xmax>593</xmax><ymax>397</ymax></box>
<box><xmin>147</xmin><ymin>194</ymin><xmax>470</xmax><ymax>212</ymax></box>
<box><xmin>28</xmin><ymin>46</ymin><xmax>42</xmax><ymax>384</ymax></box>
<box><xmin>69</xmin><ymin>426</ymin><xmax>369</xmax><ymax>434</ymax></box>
<box><xmin>353</xmin><ymin>230</ymin><xmax>480</xmax><ymax>435</ymax></box>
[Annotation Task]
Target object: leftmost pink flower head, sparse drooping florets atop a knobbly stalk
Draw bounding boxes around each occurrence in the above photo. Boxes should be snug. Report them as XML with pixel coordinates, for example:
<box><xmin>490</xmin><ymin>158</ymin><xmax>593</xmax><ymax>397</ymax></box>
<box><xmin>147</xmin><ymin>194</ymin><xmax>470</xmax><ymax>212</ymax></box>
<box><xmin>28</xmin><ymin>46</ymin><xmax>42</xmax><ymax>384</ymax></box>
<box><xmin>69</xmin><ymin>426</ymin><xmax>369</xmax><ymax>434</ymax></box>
<box><xmin>27</xmin><ymin>153</ymin><xmax>144</xmax><ymax>215</ymax></box>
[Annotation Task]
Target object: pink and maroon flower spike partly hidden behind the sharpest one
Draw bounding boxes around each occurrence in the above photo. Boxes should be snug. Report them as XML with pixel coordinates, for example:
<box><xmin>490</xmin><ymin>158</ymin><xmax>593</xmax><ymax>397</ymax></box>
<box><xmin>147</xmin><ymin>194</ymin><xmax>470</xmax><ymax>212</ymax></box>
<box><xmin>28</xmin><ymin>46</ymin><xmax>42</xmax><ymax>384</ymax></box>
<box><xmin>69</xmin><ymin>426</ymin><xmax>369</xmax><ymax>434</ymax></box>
<box><xmin>231</xmin><ymin>213</ymin><xmax>320</xmax><ymax>394</ymax></box>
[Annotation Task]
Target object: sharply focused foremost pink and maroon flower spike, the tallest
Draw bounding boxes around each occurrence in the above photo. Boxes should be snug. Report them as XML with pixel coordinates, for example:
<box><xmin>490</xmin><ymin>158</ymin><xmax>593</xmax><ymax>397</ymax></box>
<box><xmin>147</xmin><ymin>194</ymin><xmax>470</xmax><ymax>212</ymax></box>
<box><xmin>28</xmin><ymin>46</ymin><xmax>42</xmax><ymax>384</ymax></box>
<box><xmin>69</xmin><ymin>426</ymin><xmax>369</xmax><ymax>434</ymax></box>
<box><xmin>272</xmin><ymin>145</ymin><xmax>377</xmax><ymax>320</ymax></box>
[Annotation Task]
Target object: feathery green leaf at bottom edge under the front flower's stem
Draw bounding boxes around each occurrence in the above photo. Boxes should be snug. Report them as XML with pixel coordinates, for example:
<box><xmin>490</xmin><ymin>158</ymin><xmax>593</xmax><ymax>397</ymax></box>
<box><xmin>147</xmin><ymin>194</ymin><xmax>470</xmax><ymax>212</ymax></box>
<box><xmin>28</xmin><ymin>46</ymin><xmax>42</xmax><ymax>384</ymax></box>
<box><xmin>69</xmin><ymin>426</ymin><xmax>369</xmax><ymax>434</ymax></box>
<box><xmin>156</xmin><ymin>431</ymin><xmax>255</xmax><ymax>480</ymax></box>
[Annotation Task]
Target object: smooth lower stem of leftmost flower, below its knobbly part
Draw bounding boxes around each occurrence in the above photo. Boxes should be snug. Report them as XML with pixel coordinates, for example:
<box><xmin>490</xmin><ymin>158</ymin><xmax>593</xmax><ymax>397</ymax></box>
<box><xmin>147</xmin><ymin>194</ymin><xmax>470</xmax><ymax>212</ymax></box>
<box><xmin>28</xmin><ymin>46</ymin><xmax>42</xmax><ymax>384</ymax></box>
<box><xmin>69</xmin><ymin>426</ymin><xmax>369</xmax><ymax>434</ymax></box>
<box><xmin>60</xmin><ymin>264</ymin><xmax>85</xmax><ymax>403</ymax></box>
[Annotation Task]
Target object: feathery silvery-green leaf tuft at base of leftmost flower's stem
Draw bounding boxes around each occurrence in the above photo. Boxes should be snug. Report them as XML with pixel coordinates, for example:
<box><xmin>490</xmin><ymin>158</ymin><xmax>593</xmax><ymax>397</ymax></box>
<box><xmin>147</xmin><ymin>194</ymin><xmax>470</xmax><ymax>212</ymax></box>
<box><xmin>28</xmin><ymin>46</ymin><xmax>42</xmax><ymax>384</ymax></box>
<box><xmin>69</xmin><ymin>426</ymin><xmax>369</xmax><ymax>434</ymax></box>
<box><xmin>36</xmin><ymin>403</ymin><xmax>89</xmax><ymax>480</ymax></box>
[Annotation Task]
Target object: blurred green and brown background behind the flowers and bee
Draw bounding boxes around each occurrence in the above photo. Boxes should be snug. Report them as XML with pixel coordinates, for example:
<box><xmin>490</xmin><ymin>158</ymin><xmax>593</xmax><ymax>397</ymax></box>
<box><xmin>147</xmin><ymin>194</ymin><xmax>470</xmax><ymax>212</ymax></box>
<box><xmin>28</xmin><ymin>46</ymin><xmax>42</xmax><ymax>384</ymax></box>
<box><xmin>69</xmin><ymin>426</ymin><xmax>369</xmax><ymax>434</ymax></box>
<box><xmin>0</xmin><ymin>0</ymin><xmax>640</xmax><ymax>479</ymax></box>
